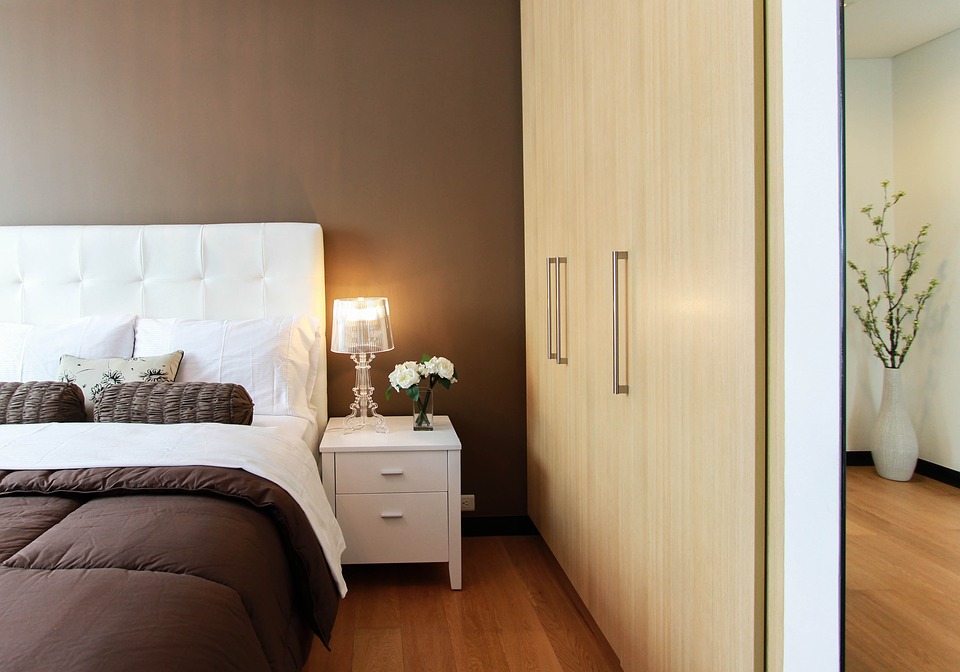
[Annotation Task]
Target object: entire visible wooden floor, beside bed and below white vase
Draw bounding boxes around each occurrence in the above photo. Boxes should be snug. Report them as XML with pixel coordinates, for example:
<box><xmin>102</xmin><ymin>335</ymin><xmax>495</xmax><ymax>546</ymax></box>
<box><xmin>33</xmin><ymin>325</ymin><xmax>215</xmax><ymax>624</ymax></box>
<box><xmin>304</xmin><ymin>467</ymin><xmax>960</xmax><ymax>672</ymax></box>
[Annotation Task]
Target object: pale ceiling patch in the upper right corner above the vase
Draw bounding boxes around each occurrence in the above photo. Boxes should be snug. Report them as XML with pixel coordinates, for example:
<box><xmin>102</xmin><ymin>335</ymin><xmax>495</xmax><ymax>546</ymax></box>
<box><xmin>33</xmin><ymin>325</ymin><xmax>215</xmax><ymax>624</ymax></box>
<box><xmin>843</xmin><ymin>0</ymin><xmax>960</xmax><ymax>58</ymax></box>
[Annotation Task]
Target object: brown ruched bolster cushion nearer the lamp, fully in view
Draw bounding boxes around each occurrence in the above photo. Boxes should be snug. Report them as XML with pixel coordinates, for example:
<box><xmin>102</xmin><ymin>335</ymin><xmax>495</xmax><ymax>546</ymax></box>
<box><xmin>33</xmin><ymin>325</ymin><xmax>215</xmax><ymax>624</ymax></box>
<box><xmin>93</xmin><ymin>382</ymin><xmax>253</xmax><ymax>425</ymax></box>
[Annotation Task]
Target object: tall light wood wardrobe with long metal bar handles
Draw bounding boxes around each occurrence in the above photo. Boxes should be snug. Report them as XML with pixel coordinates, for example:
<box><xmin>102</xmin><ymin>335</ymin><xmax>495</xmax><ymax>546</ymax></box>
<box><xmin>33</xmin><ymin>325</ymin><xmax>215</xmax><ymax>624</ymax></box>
<box><xmin>521</xmin><ymin>0</ymin><xmax>765</xmax><ymax>672</ymax></box>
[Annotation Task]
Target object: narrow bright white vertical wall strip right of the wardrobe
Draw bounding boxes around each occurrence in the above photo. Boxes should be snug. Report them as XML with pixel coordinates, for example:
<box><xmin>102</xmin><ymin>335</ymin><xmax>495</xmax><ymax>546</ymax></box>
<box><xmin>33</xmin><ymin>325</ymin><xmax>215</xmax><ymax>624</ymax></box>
<box><xmin>780</xmin><ymin>0</ymin><xmax>841</xmax><ymax>672</ymax></box>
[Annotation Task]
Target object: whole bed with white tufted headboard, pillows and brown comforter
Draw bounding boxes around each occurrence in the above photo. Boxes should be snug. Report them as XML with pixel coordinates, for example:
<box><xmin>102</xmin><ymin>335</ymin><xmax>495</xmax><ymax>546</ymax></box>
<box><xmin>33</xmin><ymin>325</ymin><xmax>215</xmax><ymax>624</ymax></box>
<box><xmin>0</xmin><ymin>222</ymin><xmax>346</xmax><ymax>672</ymax></box>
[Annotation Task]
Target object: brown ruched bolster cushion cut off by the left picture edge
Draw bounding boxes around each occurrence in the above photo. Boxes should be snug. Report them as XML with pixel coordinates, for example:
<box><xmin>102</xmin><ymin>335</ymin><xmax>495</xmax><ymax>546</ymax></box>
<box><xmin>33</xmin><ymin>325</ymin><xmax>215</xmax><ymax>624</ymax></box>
<box><xmin>0</xmin><ymin>380</ymin><xmax>87</xmax><ymax>425</ymax></box>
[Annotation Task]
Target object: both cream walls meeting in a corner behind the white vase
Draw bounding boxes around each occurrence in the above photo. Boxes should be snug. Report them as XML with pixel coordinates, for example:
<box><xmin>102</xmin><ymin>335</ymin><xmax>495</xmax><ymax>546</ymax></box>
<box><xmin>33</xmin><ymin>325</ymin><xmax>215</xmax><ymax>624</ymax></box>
<box><xmin>845</xmin><ymin>31</ymin><xmax>960</xmax><ymax>470</ymax></box>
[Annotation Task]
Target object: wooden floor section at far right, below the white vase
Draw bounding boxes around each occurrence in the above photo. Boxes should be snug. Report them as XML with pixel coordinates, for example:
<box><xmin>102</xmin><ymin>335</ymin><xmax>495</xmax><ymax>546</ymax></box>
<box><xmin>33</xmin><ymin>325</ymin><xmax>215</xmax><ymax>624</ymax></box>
<box><xmin>846</xmin><ymin>467</ymin><xmax>960</xmax><ymax>672</ymax></box>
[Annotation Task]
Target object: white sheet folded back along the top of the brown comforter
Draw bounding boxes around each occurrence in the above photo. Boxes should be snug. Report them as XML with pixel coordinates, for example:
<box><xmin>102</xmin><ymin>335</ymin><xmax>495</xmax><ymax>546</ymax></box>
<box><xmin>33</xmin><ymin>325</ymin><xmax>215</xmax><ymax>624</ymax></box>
<box><xmin>0</xmin><ymin>416</ymin><xmax>347</xmax><ymax>596</ymax></box>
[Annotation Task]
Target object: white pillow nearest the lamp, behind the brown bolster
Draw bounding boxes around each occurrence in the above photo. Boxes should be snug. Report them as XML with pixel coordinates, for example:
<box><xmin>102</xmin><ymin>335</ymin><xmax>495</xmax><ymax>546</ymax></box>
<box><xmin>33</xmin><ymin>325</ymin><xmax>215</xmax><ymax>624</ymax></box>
<box><xmin>133</xmin><ymin>317</ymin><xmax>319</xmax><ymax>420</ymax></box>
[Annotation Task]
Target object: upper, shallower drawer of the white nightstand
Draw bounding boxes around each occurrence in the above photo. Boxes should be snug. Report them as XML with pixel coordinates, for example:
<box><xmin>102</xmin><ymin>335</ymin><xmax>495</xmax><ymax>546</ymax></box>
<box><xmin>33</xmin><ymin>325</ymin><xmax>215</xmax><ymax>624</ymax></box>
<box><xmin>336</xmin><ymin>451</ymin><xmax>447</xmax><ymax>495</ymax></box>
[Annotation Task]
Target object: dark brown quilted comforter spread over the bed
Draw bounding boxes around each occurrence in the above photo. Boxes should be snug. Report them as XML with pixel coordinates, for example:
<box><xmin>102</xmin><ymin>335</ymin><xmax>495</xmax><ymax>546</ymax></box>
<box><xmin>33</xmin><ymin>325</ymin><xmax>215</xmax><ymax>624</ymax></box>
<box><xmin>0</xmin><ymin>467</ymin><xmax>339</xmax><ymax>672</ymax></box>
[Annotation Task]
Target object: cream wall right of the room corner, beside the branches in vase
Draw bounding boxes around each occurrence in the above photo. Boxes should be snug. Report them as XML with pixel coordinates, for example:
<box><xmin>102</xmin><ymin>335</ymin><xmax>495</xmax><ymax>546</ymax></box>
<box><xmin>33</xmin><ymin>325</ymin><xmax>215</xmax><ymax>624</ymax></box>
<box><xmin>893</xmin><ymin>31</ymin><xmax>960</xmax><ymax>470</ymax></box>
